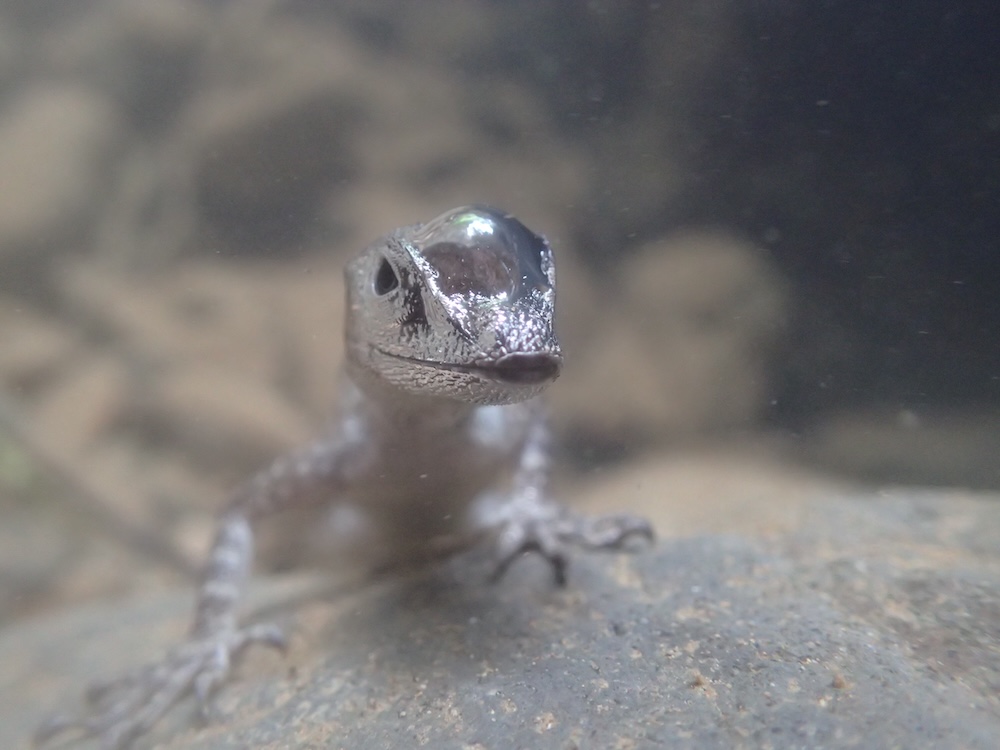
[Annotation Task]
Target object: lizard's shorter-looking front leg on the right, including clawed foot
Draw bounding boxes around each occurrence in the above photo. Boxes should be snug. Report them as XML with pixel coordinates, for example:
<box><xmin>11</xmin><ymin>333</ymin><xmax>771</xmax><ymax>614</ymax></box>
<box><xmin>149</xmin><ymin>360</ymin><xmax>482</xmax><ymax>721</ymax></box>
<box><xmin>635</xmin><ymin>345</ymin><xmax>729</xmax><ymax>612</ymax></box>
<box><xmin>493</xmin><ymin>417</ymin><xmax>654</xmax><ymax>586</ymax></box>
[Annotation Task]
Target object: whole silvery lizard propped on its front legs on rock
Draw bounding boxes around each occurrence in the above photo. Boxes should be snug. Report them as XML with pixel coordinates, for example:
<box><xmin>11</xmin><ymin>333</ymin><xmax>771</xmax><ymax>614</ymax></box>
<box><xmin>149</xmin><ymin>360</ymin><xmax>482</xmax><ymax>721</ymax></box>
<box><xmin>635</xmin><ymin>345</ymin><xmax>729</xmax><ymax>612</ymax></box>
<box><xmin>36</xmin><ymin>205</ymin><xmax>653</xmax><ymax>750</ymax></box>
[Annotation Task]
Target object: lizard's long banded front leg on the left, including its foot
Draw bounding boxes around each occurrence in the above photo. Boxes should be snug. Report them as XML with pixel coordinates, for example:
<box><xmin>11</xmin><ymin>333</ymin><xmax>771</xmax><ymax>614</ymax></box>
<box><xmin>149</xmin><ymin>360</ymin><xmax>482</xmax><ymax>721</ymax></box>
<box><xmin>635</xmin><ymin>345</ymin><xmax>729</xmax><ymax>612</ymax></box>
<box><xmin>35</xmin><ymin>439</ymin><xmax>357</xmax><ymax>750</ymax></box>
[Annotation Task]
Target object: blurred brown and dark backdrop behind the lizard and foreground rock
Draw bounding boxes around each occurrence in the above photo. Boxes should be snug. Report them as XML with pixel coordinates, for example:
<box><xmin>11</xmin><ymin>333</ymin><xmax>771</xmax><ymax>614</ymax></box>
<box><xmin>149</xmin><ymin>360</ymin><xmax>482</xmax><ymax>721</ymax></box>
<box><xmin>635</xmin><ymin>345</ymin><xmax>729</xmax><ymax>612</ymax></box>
<box><xmin>0</xmin><ymin>0</ymin><xmax>1000</xmax><ymax>621</ymax></box>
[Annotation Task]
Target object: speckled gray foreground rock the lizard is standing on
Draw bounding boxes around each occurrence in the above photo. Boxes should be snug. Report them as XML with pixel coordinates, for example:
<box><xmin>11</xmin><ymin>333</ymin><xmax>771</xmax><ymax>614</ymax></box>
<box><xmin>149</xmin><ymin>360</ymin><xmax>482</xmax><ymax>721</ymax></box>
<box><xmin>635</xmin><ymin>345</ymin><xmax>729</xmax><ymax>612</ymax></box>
<box><xmin>0</xmin><ymin>490</ymin><xmax>1000</xmax><ymax>750</ymax></box>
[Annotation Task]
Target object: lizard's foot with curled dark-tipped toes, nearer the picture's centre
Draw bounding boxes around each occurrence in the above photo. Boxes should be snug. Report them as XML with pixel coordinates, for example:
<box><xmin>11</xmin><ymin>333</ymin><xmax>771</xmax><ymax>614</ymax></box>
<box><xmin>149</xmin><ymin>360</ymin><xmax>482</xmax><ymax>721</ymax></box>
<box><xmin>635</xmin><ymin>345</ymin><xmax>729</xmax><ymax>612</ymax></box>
<box><xmin>493</xmin><ymin>513</ymin><xmax>655</xmax><ymax>586</ymax></box>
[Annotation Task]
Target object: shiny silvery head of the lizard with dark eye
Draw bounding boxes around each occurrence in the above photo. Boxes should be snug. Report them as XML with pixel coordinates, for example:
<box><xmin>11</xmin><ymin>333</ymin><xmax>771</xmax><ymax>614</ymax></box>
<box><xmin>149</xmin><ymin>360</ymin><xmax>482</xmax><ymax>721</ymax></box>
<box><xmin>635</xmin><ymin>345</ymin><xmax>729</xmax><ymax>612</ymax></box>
<box><xmin>346</xmin><ymin>206</ymin><xmax>562</xmax><ymax>404</ymax></box>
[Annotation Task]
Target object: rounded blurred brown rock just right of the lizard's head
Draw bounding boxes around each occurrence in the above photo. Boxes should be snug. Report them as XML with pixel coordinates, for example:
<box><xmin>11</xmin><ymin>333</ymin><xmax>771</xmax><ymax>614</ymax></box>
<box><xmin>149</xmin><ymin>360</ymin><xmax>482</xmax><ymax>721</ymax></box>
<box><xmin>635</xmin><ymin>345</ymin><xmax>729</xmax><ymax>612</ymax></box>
<box><xmin>552</xmin><ymin>232</ymin><xmax>788</xmax><ymax>447</ymax></box>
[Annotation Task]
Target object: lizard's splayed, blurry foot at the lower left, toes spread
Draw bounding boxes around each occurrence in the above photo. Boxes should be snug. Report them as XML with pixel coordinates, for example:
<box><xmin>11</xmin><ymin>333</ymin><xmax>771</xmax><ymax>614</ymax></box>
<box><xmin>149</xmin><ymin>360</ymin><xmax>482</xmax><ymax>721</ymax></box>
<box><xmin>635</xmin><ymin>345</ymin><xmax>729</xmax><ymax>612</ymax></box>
<box><xmin>35</xmin><ymin>625</ymin><xmax>285</xmax><ymax>750</ymax></box>
